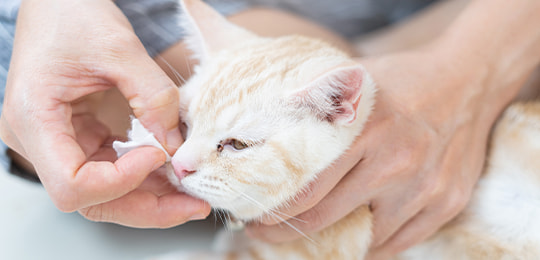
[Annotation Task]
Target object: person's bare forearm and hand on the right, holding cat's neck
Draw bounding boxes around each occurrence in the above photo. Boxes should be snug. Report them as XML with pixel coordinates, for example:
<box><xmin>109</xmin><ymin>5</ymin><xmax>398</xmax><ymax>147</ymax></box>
<box><xmin>249</xmin><ymin>0</ymin><xmax>540</xmax><ymax>259</ymax></box>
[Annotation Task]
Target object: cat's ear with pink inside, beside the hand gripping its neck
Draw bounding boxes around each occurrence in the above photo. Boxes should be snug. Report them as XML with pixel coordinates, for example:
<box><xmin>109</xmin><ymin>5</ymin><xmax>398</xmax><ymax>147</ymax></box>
<box><xmin>293</xmin><ymin>65</ymin><xmax>372</xmax><ymax>124</ymax></box>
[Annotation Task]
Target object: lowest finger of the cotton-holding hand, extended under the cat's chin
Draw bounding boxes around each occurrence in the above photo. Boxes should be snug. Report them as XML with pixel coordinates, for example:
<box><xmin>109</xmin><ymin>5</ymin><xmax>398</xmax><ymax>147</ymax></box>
<box><xmin>79</xmin><ymin>189</ymin><xmax>210</xmax><ymax>228</ymax></box>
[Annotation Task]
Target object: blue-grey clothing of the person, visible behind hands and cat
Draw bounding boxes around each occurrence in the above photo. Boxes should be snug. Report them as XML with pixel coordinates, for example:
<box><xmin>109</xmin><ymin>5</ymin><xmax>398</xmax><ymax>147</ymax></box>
<box><xmin>0</xmin><ymin>0</ymin><xmax>436</xmax><ymax>174</ymax></box>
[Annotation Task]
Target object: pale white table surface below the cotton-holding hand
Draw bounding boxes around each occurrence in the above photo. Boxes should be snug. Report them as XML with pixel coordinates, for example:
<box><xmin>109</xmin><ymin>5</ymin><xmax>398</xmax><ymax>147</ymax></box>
<box><xmin>0</xmin><ymin>171</ymin><xmax>219</xmax><ymax>260</ymax></box>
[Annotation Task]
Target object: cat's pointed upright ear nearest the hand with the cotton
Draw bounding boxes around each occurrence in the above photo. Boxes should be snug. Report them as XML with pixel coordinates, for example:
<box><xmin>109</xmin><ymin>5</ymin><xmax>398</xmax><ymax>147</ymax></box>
<box><xmin>180</xmin><ymin>0</ymin><xmax>254</xmax><ymax>63</ymax></box>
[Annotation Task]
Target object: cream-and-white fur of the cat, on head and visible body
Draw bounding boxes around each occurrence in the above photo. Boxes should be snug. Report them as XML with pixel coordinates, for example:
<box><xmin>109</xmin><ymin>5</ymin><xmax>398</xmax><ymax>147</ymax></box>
<box><xmin>158</xmin><ymin>0</ymin><xmax>540</xmax><ymax>259</ymax></box>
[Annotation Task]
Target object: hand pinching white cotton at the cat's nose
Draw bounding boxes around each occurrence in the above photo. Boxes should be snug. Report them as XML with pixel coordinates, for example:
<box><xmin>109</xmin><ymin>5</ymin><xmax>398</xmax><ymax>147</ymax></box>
<box><xmin>0</xmin><ymin>0</ymin><xmax>210</xmax><ymax>227</ymax></box>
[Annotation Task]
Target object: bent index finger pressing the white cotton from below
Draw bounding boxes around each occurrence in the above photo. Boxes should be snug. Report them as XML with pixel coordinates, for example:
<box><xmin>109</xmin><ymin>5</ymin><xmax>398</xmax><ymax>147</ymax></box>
<box><xmin>36</xmin><ymin>137</ymin><xmax>166</xmax><ymax>212</ymax></box>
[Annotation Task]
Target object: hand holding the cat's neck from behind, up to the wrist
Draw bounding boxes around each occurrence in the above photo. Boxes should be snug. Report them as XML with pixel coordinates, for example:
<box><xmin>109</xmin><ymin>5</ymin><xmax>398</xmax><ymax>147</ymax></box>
<box><xmin>248</xmin><ymin>46</ymin><xmax>515</xmax><ymax>259</ymax></box>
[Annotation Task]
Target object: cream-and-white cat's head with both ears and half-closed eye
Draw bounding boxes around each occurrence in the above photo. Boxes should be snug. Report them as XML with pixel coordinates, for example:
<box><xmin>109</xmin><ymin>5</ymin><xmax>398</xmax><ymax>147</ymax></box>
<box><xmin>169</xmin><ymin>0</ymin><xmax>374</xmax><ymax>220</ymax></box>
